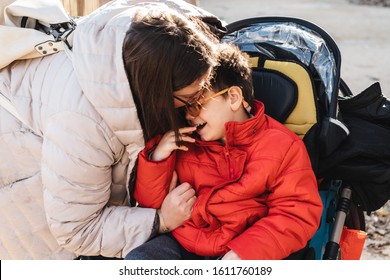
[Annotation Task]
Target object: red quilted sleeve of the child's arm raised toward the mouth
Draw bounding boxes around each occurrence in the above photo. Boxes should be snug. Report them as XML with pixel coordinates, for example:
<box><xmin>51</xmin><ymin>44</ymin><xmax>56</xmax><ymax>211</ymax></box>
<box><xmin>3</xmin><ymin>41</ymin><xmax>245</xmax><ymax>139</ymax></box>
<box><xmin>134</xmin><ymin>137</ymin><xmax>176</xmax><ymax>209</ymax></box>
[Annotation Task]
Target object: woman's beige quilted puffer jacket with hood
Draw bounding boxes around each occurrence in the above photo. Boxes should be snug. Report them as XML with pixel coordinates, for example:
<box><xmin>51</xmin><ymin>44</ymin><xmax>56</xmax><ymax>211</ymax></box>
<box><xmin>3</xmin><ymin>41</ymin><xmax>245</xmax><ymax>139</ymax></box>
<box><xmin>0</xmin><ymin>0</ymin><xmax>219</xmax><ymax>259</ymax></box>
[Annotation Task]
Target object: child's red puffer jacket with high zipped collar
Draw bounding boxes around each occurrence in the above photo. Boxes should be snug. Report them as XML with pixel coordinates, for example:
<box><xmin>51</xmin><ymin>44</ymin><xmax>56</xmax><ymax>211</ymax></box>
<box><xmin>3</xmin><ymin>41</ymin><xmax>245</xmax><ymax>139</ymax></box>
<box><xmin>135</xmin><ymin>102</ymin><xmax>322</xmax><ymax>259</ymax></box>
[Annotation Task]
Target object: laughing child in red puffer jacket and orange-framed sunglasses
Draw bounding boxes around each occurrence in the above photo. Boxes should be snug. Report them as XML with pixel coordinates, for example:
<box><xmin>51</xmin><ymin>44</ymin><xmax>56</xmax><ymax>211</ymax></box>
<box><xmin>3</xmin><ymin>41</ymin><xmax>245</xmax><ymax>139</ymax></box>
<box><xmin>126</xmin><ymin>44</ymin><xmax>322</xmax><ymax>259</ymax></box>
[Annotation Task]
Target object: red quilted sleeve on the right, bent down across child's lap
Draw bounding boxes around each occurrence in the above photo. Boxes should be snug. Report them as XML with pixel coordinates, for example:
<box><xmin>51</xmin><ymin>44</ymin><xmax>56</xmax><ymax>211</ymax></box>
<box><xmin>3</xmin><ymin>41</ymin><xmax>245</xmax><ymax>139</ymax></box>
<box><xmin>228</xmin><ymin>141</ymin><xmax>322</xmax><ymax>259</ymax></box>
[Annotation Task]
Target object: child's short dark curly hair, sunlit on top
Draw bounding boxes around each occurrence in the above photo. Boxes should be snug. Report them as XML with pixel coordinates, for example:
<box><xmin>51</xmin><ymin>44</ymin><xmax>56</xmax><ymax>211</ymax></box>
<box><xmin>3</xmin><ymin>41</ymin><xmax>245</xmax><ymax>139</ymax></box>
<box><xmin>211</xmin><ymin>43</ymin><xmax>254</xmax><ymax>105</ymax></box>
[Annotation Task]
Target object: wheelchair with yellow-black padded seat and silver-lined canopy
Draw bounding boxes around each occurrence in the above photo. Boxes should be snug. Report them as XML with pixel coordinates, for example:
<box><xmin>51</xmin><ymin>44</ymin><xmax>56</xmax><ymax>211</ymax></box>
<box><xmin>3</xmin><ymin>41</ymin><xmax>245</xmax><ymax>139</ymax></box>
<box><xmin>221</xmin><ymin>17</ymin><xmax>365</xmax><ymax>260</ymax></box>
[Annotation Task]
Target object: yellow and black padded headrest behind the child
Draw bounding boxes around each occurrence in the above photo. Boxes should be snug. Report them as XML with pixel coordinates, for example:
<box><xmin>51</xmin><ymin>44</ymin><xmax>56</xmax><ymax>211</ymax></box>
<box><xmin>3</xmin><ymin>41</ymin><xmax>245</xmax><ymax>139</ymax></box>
<box><xmin>250</xmin><ymin>57</ymin><xmax>317</xmax><ymax>138</ymax></box>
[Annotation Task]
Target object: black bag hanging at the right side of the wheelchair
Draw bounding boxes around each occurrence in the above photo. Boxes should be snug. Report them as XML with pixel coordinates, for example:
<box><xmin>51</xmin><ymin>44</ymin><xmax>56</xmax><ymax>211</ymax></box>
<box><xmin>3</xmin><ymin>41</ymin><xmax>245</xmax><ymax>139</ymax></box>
<box><xmin>320</xmin><ymin>83</ymin><xmax>390</xmax><ymax>211</ymax></box>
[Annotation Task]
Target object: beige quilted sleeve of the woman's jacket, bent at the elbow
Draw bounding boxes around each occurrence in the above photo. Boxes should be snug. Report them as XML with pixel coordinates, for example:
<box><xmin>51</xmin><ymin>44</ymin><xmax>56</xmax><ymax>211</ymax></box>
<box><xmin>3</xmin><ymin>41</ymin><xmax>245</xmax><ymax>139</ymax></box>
<box><xmin>42</xmin><ymin>111</ymin><xmax>155</xmax><ymax>257</ymax></box>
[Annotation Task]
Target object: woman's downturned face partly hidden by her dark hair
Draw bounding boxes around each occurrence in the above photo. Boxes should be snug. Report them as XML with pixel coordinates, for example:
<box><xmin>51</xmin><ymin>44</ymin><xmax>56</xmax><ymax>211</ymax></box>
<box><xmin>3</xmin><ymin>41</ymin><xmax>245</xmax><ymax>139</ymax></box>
<box><xmin>173</xmin><ymin>68</ymin><xmax>211</xmax><ymax>108</ymax></box>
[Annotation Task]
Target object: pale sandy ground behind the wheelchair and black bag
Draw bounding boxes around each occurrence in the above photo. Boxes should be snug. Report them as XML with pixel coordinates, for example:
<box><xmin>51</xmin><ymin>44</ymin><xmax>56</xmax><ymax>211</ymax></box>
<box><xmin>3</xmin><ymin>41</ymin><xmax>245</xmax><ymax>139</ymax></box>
<box><xmin>198</xmin><ymin>0</ymin><xmax>390</xmax><ymax>260</ymax></box>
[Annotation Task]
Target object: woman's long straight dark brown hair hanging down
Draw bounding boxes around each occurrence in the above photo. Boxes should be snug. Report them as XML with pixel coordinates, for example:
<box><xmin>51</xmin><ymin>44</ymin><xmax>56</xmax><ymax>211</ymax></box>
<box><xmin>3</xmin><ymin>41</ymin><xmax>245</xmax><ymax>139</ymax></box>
<box><xmin>123</xmin><ymin>10</ymin><xmax>217</xmax><ymax>141</ymax></box>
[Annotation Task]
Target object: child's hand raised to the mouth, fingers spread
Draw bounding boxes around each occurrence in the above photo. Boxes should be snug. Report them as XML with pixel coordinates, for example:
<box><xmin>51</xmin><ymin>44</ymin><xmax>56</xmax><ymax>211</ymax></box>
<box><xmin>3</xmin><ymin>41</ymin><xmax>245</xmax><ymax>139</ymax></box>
<box><xmin>150</xmin><ymin>127</ymin><xmax>196</xmax><ymax>161</ymax></box>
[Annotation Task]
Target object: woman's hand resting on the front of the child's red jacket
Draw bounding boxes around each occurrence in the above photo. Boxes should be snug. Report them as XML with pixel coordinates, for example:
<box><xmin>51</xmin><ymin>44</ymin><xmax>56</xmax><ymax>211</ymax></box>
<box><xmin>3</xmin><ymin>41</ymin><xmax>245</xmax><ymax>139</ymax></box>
<box><xmin>158</xmin><ymin>172</ymin><xmax>196</xmax><ymax>232</ymax></box>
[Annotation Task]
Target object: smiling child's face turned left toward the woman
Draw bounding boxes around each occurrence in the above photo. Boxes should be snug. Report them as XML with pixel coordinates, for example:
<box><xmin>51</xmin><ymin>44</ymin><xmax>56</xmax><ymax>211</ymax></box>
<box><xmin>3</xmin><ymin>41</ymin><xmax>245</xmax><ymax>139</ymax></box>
<box><xmin>186</xmin><ymin>88</ymin><xmax>236</xmax><ymax>142</ymax></box>
